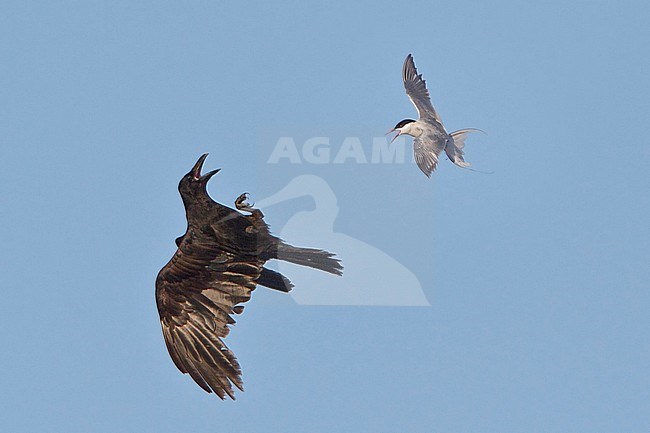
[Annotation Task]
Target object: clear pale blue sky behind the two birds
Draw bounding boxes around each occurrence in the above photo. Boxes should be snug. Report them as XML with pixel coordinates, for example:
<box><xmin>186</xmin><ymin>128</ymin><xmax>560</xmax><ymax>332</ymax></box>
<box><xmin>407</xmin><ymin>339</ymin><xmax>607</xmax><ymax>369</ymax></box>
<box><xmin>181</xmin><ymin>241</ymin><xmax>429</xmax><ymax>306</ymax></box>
<box><xmin>0</xmin><ymin>1</ymin><xmax>650</xmax><ymax>433</ymax></box>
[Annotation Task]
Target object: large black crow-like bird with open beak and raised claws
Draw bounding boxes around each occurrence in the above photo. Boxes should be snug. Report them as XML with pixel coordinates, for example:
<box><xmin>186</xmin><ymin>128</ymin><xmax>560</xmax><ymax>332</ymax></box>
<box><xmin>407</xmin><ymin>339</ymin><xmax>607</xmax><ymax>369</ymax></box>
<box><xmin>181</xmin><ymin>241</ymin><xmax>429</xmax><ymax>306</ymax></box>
<box><xmin>156</xmin><ymin>153</ymin><xmax>343</xmax><ymax>400</ymax></box>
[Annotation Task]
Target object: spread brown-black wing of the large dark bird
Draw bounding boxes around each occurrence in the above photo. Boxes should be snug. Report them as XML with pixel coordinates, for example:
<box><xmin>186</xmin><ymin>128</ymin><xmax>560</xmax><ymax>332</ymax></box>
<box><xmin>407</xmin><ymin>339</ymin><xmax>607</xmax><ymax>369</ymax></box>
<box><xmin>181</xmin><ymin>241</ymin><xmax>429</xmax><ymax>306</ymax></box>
<box><xmin>156</xmin><ymin>235</ymin><xmax>263</xmax><ymax>400</ymax></box>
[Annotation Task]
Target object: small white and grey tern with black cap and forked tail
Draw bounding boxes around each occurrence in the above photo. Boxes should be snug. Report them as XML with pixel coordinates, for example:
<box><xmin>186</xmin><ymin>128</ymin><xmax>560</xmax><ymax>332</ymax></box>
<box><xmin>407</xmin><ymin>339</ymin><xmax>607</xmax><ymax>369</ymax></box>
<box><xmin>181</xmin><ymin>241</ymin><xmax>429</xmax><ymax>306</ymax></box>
<box><xmin>386</xmin><ymin>54</ymin><xmax>482</xmax><ymax>177</ymax></box>
